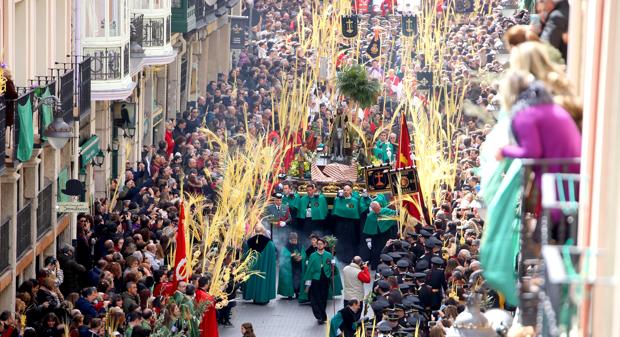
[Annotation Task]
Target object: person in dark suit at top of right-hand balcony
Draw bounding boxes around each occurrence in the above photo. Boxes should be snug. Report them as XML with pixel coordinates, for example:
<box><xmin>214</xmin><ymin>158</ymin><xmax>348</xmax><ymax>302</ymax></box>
<box><xmin>540</xmin><ymin>0</ymin><xmax>570</xmax><ymax>60</ymax></box>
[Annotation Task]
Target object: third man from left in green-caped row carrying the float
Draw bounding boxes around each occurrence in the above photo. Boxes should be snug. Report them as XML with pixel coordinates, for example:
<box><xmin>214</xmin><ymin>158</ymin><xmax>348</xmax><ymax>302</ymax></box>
<box><xmin>332</xmin><ymin>185</ymin><xmax>360</xmax><ymax>261</ymax></box>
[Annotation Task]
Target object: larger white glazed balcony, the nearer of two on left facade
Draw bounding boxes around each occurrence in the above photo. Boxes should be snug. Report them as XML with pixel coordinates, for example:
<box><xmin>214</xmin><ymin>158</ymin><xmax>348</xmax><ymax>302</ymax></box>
<box><xmin>80</xmin><ymin>0</ymin><xmax>139</xmax><ymax>101</ymax></box>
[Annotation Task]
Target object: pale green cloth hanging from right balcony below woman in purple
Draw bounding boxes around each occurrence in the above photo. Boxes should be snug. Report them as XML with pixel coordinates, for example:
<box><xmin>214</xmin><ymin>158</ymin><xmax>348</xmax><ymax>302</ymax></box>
<box><xmin>480</xmin><ymin>159</ymin><xmax>523</xmax><ymax>305</ymax></box>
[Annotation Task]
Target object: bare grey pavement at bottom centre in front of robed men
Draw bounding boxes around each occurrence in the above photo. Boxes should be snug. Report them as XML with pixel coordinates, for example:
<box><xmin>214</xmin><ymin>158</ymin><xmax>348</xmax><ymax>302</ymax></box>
<box><xmin>219</xmin><ymin>296</ymin><xmax>342</xmax><ymax>337</ymax></box>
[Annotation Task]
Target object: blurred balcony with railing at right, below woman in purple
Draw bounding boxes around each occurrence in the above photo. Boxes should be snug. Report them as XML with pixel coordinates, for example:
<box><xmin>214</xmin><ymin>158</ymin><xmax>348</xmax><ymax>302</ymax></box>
<box><xmin>518</xmin><ymin>158</ymin><xmax>587</xmax><ymax>330</ymax></box>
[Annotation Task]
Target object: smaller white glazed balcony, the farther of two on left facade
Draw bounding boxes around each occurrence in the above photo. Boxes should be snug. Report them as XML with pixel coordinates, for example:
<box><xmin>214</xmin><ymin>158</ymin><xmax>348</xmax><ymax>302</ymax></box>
<box><xmin>131</xmin><ymin>0</ymin><xmax>177</xmax><ymax>65</ymax></box>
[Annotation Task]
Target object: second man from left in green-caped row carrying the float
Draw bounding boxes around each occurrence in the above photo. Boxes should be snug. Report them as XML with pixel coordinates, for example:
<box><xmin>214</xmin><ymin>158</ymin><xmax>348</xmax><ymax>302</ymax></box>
<box><xmin>296</xmin><ymin>183</ymin><xmax>327</xmax><ymax>239</ymax></box>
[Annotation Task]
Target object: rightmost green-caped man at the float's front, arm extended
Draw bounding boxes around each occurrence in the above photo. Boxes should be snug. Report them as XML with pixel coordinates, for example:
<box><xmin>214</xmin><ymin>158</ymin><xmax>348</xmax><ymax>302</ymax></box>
<box><xmin>362</xmin><ymin>201</ymin><xmax>396</xmax><ymax>270</ymax></box>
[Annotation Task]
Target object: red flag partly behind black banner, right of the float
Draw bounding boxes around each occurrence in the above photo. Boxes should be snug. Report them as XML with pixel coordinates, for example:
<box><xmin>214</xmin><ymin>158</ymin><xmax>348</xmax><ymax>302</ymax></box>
<box><xmin>396</xmin><ymin>113</ymin><xmax>425</xmax><ymax>223</ymax></box>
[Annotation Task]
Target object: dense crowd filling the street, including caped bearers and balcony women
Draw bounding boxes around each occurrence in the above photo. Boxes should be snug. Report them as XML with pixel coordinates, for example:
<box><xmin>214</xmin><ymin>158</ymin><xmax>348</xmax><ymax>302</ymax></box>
<box><xmin>0</xmin><ymin>0</ymin><xmax>581</xmax><ymax>337</ymax></box>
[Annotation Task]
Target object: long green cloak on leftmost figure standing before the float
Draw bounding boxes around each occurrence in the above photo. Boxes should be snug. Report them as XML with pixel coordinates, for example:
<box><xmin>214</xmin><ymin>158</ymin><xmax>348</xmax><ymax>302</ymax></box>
<box><xmin>243</xmin><ymin>240</ymin><xmax>276</xmax><ymax>303</ymax></box>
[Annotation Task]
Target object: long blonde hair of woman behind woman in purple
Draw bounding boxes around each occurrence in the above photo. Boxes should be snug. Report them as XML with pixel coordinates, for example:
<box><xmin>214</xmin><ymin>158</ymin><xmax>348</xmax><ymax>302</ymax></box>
<box><xmin>510</xmin><ymin>41</ymin><xmax>583</xmax><ymax>129</ymax></box>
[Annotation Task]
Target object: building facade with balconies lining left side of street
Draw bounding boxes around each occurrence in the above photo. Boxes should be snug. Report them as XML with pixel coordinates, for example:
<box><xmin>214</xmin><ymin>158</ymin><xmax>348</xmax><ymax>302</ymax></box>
<box><xmin>0</xmin><ymin>0</ymin><xmax>241</xmax><ymax>308</ymax></box>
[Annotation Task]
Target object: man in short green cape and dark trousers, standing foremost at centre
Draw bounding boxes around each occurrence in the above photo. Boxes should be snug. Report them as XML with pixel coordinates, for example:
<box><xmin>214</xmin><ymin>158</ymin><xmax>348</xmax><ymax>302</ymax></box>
<box><xmin>304</xmin><ymin>238</ymin><xmax>335</xmax><ymax>324</ymax></box>
